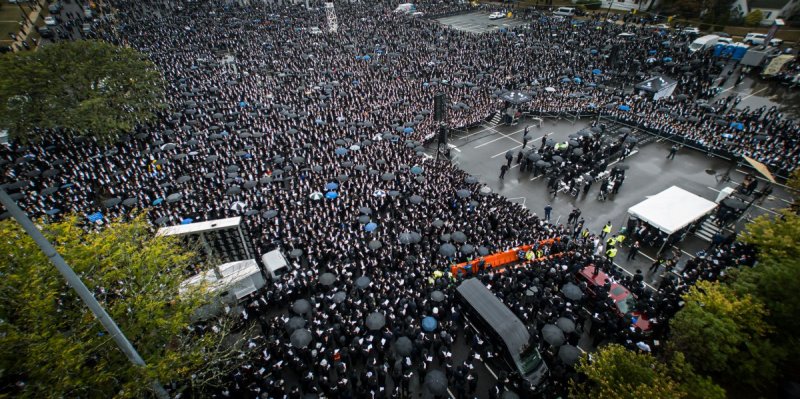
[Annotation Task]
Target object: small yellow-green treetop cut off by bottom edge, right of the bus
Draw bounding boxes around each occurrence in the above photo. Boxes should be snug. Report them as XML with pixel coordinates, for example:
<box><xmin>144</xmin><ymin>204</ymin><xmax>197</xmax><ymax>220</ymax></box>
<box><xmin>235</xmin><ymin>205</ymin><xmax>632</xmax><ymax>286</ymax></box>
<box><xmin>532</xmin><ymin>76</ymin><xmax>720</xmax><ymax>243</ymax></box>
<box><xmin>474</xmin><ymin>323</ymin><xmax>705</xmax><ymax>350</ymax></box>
<box><xmin>570</xmin><ymin>344</ymin><xmax>687</xmax><ymax>399</ymax></box>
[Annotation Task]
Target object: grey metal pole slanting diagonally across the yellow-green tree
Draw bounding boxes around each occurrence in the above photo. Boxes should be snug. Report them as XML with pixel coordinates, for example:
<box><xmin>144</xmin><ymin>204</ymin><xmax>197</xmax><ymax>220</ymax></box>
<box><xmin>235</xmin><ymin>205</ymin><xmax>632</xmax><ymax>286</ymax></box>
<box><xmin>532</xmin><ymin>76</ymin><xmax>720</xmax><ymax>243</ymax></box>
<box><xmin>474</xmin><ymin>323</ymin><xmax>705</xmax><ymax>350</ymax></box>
<box><xmin>0</xmin><ymin>188</ymin><xmax>169</xmax><ymax>399</ymax></box>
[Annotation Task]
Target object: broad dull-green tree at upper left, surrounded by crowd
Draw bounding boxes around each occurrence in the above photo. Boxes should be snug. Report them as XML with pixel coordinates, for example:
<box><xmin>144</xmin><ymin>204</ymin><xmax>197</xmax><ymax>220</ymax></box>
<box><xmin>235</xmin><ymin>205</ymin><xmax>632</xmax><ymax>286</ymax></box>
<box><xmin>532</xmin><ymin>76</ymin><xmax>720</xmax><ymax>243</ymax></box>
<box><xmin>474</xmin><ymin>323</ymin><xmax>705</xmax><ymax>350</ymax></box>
<box><xmin>0</xmin><ymin>40</ymin><xmax>164</xmax><ymax>142</ymax></box>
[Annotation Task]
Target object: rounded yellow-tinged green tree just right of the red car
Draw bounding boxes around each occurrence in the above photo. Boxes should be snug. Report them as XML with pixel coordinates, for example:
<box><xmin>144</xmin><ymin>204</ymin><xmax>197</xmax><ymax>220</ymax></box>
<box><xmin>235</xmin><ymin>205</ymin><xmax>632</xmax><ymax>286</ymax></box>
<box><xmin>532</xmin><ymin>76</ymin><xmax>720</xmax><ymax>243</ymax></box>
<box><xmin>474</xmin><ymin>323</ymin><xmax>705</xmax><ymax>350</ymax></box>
<box><xmin>670</xmin><ymin>281</ymin><xmax>780</xmax><ymax>388</ymax></box>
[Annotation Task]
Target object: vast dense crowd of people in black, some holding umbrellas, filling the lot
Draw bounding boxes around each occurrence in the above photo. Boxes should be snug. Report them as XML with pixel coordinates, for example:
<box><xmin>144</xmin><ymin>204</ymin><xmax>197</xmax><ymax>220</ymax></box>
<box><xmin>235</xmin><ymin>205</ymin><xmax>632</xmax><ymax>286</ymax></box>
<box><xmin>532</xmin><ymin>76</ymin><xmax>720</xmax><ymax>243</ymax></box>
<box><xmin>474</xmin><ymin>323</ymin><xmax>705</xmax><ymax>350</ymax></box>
<box><xmin>0</xmin><ymin>0</ymin><xmax>800</xmax><ymax>398</ymax></box>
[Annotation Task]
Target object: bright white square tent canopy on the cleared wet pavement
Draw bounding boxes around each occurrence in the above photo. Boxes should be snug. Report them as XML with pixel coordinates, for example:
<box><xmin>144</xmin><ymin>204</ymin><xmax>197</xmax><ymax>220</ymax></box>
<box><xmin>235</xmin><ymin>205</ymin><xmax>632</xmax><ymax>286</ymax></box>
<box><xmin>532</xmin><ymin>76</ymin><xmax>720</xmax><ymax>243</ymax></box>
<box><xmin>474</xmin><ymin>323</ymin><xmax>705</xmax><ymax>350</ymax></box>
<box><xmin>628</xmin><ymin>186</ymin><xmax>717</xmax><ymax>234</ymax></box>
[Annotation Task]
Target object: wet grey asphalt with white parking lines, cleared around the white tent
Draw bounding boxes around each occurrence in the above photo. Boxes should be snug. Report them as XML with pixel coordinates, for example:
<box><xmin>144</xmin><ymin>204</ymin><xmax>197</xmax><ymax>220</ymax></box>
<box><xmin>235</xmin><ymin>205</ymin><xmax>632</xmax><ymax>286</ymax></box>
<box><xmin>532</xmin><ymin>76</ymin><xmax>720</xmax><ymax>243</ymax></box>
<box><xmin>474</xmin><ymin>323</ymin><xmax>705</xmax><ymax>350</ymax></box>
<box><xmin>433</xmin><ymin>118</ymin><xmax>790</xmax><ymax>287</ymax></box>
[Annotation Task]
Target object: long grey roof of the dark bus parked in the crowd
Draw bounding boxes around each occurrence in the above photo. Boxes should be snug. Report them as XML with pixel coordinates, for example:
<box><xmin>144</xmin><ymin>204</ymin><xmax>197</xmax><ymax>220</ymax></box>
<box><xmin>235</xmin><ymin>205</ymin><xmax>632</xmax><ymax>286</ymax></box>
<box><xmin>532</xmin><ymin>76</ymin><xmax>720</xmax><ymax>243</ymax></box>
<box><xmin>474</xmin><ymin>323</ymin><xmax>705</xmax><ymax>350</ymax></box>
<box><xmin>456</xmin><ymin>277</ymin><xmax>530</xmax><ymax>357</ymax></box>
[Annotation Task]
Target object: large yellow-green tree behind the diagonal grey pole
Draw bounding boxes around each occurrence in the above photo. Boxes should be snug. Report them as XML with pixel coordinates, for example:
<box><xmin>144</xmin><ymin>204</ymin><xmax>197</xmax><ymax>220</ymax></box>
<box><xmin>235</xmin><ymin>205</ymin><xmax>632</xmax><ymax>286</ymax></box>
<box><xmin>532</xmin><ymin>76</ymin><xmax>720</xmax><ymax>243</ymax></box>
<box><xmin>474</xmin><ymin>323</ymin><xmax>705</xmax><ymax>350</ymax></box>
<box><xmin>0</xmin><ymin>215</ymin><xmax>244</xmax><ymax>398</ymax></box>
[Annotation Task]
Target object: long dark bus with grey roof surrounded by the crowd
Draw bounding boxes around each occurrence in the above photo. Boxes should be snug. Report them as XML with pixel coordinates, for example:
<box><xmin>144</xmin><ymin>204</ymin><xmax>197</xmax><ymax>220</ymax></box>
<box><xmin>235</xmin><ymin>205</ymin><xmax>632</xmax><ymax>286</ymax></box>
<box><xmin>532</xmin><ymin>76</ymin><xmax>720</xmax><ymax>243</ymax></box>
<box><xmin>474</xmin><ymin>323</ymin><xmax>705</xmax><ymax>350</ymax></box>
<box><xmin>456</xmin><ymin>277</ymin><xmax>548</xmax><ymax>391</ymax></box>
